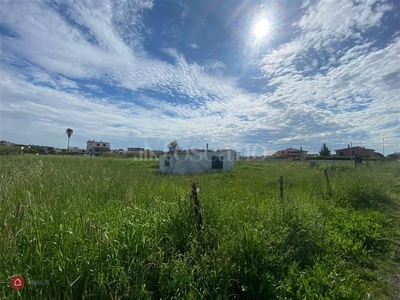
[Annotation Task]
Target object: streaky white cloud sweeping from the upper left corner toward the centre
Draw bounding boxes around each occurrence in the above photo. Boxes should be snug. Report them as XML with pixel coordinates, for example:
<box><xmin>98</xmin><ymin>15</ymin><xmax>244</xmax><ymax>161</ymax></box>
<box><xmin>3</xmin><ymin>1</ymin><xmax>247</xmax><ymax>105</ymax></box>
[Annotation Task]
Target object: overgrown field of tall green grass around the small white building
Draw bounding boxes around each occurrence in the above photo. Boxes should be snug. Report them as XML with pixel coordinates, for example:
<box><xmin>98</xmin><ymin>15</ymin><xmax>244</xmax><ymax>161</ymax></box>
<box><xmin>0</xmin><ymin>156</ymin><xmax>400</xmax><ymax>299</ymax></box>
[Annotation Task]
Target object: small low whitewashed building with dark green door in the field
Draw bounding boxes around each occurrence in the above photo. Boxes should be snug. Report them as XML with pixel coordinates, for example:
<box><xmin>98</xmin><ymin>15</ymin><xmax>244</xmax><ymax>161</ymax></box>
<box><xmin>159</xmin><ymin>150</ymin><xmax>236</xmax><ymax>174</ymax></box>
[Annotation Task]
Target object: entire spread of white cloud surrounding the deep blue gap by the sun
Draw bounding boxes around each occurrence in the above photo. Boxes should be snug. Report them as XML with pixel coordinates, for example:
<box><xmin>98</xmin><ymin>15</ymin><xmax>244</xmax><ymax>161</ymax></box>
<box><xmin>0</xmin><ymin>1</ymin><xmax>400</xmax><ymax>154</ymax></box>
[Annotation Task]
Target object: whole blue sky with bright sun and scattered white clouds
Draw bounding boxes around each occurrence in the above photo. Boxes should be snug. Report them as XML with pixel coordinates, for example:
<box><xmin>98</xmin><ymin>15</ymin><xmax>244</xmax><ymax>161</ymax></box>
<box><xmin>0</xmin><ymin>0</ymin><xmax>400</xmax><ymax>155</ymax></box>
